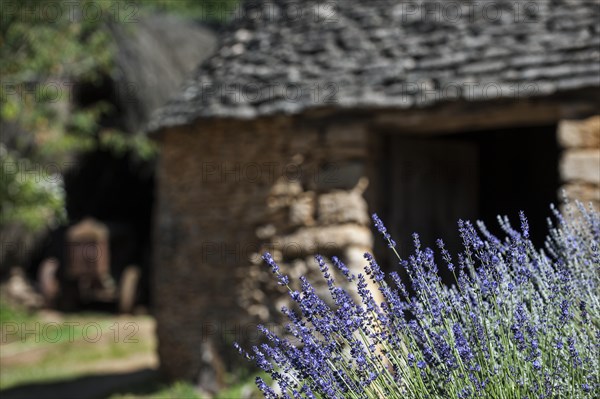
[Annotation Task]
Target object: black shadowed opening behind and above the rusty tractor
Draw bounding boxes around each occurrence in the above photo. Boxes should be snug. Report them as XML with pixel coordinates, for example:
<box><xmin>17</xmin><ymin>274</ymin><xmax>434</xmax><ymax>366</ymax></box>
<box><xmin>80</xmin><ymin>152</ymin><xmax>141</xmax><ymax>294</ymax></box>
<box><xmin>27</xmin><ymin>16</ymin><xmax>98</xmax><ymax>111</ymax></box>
<box><xmin>65</xmin><ymin>150</ymin><xmax>154</xmax><ymax>310</ymax></box>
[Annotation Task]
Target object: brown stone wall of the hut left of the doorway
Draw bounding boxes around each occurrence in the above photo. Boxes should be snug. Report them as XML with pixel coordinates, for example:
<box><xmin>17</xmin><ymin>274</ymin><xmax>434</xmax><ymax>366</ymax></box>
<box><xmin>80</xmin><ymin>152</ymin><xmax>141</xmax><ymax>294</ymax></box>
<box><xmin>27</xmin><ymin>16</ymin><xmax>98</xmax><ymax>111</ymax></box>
<box><xmin>153</xmin><ymin>118</ymin><xmax>373</xmax><ymax>390</ymax></box>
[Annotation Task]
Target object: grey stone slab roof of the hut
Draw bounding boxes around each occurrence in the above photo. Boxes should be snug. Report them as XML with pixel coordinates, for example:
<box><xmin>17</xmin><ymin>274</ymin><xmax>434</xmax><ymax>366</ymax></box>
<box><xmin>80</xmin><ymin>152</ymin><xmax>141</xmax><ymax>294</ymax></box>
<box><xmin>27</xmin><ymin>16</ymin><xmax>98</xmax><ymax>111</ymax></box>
<box><xmin>149</xmin><ymin>0</ymin><xmax>600</xmax><ymax>131</ymax></box>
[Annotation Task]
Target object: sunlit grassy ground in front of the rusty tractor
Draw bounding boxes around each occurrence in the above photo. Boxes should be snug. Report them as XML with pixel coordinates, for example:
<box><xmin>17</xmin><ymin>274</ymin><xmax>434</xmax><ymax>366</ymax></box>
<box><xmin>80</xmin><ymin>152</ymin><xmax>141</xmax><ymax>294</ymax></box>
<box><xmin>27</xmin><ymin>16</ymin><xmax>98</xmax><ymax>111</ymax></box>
<box><xmin>0</xmin><ymin>301</ymin><xmax>156</xmax><ymax>389</ymax></box>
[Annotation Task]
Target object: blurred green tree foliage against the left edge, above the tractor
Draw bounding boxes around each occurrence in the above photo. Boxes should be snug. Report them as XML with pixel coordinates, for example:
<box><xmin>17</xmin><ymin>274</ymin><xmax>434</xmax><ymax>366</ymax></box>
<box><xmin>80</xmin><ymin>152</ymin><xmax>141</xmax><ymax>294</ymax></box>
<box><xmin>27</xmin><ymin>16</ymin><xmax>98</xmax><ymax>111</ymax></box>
<box><xmin>0</xmin><ymin>0</ymin><xmax>114</xmax><ymax>231</ymax></box>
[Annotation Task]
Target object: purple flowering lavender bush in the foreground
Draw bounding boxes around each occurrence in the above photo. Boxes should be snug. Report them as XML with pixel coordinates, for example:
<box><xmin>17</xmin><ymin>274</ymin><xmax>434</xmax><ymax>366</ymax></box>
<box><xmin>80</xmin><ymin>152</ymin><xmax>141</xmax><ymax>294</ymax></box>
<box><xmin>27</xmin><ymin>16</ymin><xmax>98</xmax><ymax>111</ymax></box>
<box><xmin>236</xmin><ymin>204</ymin><xmax>600</xmax><ymax>399</ymax></box>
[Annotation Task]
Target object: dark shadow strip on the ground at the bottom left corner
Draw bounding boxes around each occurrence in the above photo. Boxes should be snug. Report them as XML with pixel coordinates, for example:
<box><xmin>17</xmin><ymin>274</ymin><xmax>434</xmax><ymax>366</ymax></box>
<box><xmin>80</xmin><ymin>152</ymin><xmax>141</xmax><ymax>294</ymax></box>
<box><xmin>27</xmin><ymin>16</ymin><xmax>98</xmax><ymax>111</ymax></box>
<box><xmin>0</xmin><ymin>368</ymin><xmax>160</xmax><ymax>399</ymax></box>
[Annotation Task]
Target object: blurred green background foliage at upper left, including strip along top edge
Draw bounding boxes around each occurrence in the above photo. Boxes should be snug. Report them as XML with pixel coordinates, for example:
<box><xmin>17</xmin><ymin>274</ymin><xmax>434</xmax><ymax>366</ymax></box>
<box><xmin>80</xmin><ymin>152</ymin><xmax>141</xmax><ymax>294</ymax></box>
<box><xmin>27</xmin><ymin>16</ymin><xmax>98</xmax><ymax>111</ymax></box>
<box><xmin>0</xmin><ymin>0</ymin><xmax>238</xmax><ymax>238</ymax></box>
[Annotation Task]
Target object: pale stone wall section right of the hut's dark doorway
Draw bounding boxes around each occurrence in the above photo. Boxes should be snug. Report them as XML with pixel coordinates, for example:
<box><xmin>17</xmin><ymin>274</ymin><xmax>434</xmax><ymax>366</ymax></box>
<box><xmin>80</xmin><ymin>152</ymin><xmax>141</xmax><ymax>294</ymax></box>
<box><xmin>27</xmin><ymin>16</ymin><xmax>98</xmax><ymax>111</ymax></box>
<box><xmin>558</xmin><ymin>115</ymin><xmax>600</xmax><ymax>209</ymax></box>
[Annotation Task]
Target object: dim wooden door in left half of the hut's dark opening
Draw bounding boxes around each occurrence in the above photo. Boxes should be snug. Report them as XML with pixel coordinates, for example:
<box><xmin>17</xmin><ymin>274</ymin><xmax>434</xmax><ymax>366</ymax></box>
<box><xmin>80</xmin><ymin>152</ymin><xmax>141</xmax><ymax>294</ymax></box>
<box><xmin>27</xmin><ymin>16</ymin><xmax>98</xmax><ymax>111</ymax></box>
<box><xmin>387</xmin><ymin>136</ymin><xmax>480</xmax><ymax>255</ymax></box>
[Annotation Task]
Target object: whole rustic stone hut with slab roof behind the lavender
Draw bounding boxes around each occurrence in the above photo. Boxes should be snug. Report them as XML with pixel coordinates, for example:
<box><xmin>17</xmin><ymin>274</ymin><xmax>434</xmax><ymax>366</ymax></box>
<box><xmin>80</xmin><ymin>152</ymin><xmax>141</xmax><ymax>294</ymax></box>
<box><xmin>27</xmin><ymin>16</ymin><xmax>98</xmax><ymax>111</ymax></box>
<box><xmin>150</xmin><ymin>0</ymin><xmax>600</xmax><ymax>386</ymax></box>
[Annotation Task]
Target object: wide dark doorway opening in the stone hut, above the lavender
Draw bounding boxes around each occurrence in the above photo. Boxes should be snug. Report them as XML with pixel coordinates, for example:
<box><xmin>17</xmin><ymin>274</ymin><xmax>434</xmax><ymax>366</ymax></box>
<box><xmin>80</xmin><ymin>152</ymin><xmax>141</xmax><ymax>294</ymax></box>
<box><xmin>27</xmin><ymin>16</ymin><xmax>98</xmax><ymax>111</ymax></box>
<box><xmin>382</xmin><ymin>125</ymin><xmax>559</xmax><ymax>257</ymax></box>
